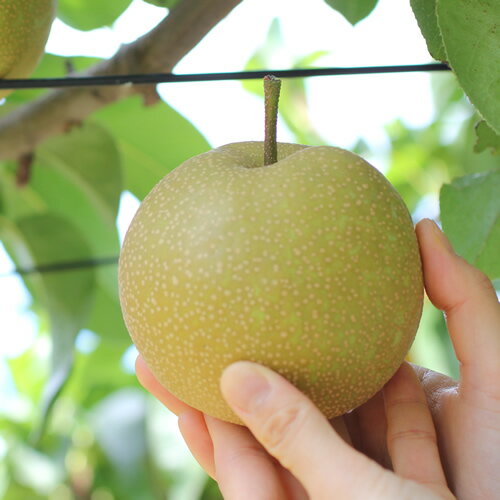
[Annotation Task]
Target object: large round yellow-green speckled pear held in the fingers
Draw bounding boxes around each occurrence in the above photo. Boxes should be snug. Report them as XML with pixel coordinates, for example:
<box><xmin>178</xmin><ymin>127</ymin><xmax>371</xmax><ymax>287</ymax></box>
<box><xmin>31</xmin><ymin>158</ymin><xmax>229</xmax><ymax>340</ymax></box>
<box><xmin>119</xmin><ymin>142</ymin><xmax>423</xmax><ymax>423</ymax></box>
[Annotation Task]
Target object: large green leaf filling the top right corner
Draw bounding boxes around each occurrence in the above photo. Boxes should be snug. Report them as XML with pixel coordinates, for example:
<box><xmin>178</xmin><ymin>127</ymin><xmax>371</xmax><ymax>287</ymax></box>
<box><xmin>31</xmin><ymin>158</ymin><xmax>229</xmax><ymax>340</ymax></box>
<box><xmin>437</xmin><ymin>0</ymin><xmax>500</xmax><ymax>134</ymax></box>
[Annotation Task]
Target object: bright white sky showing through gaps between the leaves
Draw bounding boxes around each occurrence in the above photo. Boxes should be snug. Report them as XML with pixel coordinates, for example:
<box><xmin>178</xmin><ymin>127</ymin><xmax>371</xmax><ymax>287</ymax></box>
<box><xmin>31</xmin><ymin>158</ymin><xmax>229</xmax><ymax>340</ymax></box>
<box><xmin>0</xmin><ymin>0</ymin><xmax>467</xmax><ymax>500</ymax></box>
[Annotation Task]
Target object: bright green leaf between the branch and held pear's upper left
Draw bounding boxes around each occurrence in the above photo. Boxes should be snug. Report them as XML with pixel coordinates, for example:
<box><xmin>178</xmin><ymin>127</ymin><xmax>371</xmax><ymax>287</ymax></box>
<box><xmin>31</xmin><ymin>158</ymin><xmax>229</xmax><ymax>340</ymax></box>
<box><xmin>93</xmin><ymin>97</ymin><xmax>210</xmax><ymax>199</ymax></box>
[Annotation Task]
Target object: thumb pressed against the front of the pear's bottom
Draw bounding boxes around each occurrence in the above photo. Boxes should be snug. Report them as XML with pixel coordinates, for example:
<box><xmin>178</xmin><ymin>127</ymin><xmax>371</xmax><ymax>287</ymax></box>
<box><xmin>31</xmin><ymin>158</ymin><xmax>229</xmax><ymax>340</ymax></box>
<box><xmin>221</xmin><ymin>361</ymin><xmax>385</xmax><ymax>498</ymax></box>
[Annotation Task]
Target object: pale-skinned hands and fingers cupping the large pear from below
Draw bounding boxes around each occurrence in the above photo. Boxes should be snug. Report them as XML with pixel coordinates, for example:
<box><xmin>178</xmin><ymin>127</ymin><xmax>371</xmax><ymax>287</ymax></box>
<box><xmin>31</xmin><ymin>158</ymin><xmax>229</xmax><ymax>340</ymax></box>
<box><xmin>136</xmin><ymin>220</ymin><xmax>500</xmax><ymax>500</ymax></box>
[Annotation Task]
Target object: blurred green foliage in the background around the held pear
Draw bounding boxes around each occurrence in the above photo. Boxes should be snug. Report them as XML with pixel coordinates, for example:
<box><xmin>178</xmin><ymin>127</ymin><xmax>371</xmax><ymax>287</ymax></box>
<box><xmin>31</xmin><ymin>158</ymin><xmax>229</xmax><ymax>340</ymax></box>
<box><xmin>0</xmin><ymin>0</ymin><xmax>499</xmax><ymax>500</ymax></box>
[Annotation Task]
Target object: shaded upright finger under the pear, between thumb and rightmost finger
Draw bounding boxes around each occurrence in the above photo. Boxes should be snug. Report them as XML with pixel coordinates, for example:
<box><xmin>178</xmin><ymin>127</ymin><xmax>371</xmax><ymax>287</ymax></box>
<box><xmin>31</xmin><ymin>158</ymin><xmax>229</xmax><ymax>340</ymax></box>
<box><xmin>384</xmin><ymin>363</ymin><xmax>446</xmax><ymax>486</ymax></box>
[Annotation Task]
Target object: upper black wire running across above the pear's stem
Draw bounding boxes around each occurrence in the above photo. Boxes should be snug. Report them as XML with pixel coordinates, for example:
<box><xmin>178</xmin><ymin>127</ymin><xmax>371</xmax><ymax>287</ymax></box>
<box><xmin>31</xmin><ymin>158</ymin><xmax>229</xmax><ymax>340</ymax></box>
<box><xmin>0</xmin><ymin>63</ymin><xmax>450</xmax><ymax>89</ymax></box>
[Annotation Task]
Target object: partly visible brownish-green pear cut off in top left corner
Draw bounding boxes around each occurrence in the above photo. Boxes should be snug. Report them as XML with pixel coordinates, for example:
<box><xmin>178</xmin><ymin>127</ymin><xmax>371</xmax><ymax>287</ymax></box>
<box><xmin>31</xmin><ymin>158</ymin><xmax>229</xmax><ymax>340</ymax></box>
<box><xmin>0</xmin><ymin>0</ymin><xmax>56</xmax><ymax>99</ymax></box>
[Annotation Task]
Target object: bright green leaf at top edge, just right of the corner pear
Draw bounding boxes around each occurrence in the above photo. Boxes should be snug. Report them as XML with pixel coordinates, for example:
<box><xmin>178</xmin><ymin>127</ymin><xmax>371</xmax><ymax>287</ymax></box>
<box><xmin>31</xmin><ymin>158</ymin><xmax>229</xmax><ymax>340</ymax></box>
<box><xmin>57</xmin><ymin>0</ymin><xmax>132</xmax><ymax>31</ymax></box>
